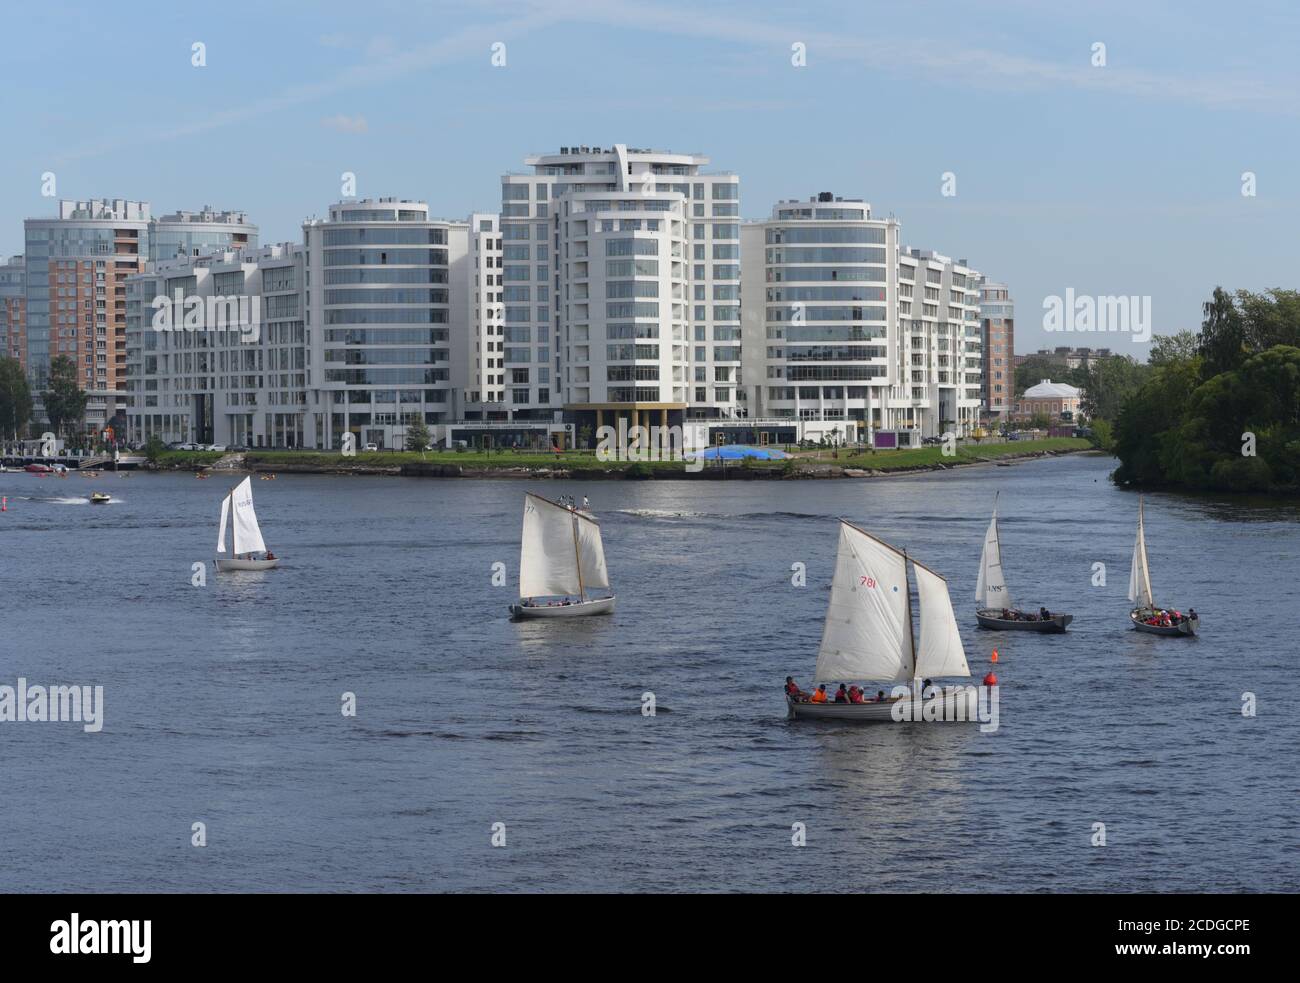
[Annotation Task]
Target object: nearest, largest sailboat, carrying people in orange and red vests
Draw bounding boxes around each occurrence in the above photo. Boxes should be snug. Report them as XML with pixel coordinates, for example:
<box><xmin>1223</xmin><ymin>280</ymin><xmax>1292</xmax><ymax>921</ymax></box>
<box><xmin>785</xmin><ymin>519</ymin><xmax>975</xmax><ymax>723</ymax></box>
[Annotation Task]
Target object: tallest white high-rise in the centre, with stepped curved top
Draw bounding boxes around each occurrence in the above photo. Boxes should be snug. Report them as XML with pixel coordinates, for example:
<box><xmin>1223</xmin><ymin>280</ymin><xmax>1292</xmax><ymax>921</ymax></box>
<box><xmin>501</xmin><ymin>144</ymin><xmax>742</xmax><ymax>433</ymax></box>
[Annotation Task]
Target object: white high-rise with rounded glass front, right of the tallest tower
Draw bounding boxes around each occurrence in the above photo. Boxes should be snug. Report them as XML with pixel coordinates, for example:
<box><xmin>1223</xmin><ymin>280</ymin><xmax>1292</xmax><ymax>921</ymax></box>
<box><xmin>741</xmin><ymin>192</ymin><xmax>980</xmax><ymax>442</ymax></box>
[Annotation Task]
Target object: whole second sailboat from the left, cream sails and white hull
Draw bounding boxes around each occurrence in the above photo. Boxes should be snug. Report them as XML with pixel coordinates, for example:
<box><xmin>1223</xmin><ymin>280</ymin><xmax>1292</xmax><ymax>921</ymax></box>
<box><xmin>510</xmin><ymin>492</ymin><xmax>614</xmax><ymax>618</ymax></box>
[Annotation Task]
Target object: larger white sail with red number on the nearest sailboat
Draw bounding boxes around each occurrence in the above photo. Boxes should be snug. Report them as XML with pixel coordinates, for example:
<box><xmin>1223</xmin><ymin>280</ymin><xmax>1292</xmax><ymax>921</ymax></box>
<box><xmin>814</xmin><ymin>523</ymin><xmax>913</xmax><ymax>683</ymax></box>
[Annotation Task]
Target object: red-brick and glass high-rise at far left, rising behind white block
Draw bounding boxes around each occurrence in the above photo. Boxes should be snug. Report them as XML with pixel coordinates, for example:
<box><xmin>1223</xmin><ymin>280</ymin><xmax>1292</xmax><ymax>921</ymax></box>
<box><xmin>25</xmin><ymin>198</ymin><xmax>257</xmax><ymax>430</ymax></box>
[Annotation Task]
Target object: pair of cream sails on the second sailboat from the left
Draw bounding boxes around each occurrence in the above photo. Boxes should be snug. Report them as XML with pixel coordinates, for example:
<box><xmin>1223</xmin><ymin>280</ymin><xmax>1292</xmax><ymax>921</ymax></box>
<box><xmin>519</xmin><ymin>493</ymin><xmax>610</xmax><ymax>597</ymax></box>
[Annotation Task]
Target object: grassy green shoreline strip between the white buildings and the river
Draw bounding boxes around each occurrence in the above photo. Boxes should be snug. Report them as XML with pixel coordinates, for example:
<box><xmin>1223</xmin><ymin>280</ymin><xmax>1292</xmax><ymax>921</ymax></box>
<box><xmin>143</xmin><ymin>438</ymin><xmax>1104</xmax><ymax>481</ymax></box>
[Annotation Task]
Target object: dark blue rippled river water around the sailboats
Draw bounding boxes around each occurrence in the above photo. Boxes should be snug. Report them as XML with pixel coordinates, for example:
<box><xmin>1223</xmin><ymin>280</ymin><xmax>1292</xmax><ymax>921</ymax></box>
<box><xmin>0</xmin><ymin>456</ymin><xmax>1300</xmax><ymax>891</ymax></box>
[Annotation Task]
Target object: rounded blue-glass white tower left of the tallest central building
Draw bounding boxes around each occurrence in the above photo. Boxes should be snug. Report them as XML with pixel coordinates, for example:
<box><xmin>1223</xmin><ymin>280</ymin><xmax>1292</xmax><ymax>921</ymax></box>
<box><xmin>303</xmin><ymin>198</ymin><xmax>469</xmax><ymax>447</ymax></box>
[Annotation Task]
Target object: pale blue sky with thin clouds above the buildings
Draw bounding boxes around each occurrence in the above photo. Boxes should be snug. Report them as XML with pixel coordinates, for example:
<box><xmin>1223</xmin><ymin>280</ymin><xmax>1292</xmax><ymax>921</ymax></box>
<box><xmin>0</xmin><ymin>0</ymin><xmax>1300</xmax><ymax>355</ymax></box>
